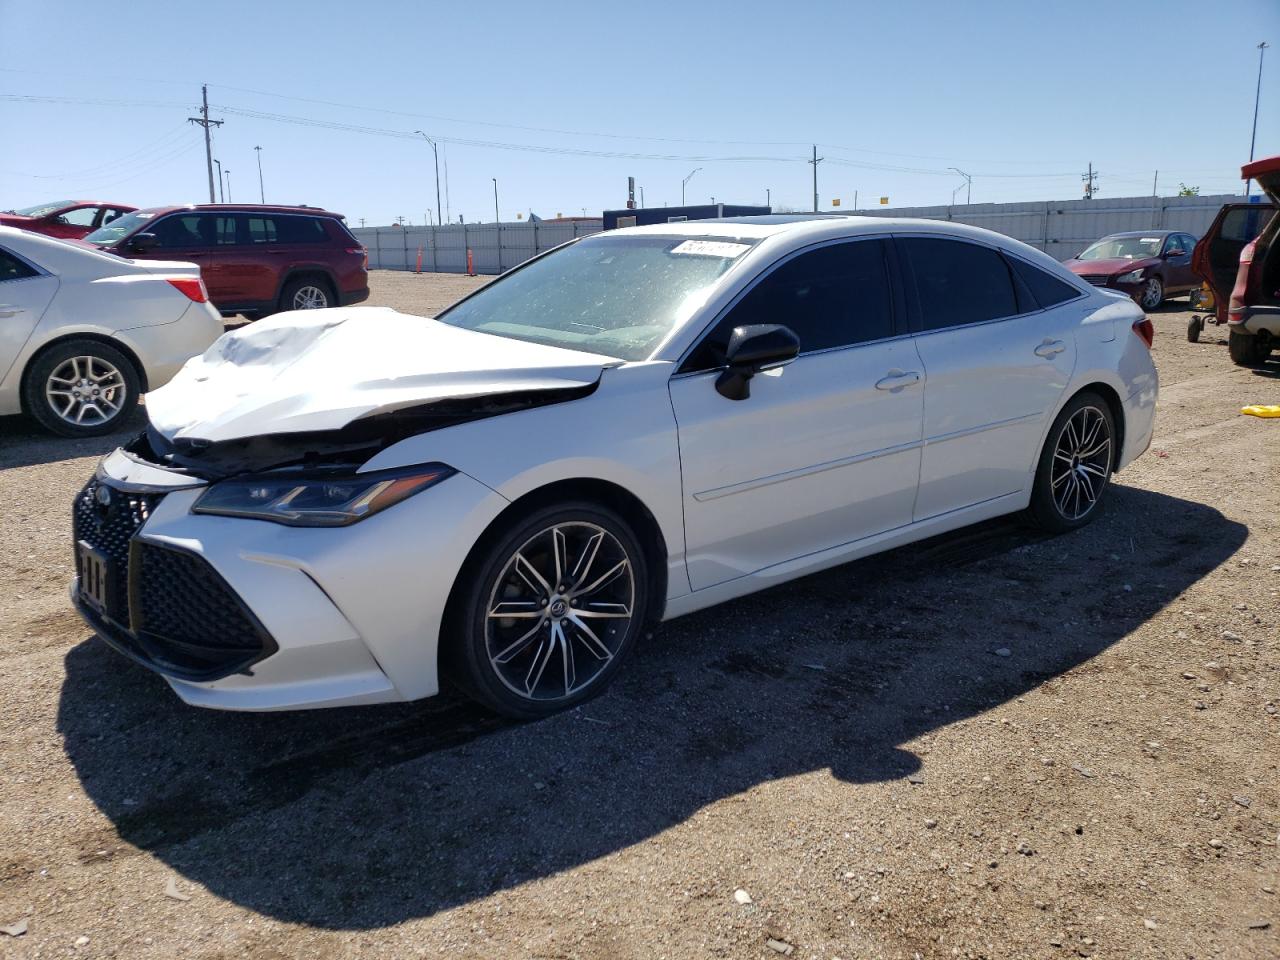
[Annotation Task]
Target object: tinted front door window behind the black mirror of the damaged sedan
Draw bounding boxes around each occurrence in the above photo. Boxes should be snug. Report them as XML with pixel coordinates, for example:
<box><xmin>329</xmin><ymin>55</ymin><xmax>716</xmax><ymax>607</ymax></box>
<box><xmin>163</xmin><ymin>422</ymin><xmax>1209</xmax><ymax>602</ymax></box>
<box><xmin>682</xmin><ymin>239</ymin><xmax>895</xmax><ymax>371</ymax></box>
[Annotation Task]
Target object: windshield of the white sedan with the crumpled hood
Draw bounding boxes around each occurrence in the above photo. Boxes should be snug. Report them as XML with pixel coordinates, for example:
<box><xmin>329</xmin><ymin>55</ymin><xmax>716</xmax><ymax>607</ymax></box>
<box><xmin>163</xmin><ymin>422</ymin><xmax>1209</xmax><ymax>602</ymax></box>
<box><xmin>438</xmin><ymin>236</ymin><xmax>751</xmax><ymax>360</ymax></box>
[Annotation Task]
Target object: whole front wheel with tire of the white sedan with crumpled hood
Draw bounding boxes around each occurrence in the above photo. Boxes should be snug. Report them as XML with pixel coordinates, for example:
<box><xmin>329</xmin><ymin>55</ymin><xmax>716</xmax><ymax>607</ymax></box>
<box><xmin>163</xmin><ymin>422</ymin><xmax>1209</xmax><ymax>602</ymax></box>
<box><xmin>440</xmin><ymin>502</ymin><xmax>649</xmax><ymax>719</ymax></box>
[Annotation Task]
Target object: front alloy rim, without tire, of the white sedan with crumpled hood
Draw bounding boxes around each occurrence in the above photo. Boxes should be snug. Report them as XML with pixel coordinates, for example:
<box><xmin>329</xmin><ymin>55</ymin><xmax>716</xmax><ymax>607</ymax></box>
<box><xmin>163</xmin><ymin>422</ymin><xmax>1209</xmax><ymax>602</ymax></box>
<box><xmin>485</xmin><ymin>521</ymin><xmax>636</xmax><ymax>701</ymax></box>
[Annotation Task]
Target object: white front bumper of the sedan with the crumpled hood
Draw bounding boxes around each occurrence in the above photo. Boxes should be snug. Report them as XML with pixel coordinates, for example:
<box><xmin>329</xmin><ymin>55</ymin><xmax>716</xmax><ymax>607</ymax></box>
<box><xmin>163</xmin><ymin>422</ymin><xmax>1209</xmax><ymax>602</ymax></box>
<box><xmin>72</xmin><ymin>457</ymin><xmax>507</xmax><ymax>710</ymax></box>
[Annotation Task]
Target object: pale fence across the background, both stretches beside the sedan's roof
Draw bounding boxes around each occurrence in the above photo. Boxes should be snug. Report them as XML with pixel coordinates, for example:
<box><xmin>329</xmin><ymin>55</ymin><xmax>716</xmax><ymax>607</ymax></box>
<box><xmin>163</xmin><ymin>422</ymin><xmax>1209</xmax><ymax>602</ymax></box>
<box><xmin>353</xmin><ymin>193</ymin><xmax>1242</xmax><ymax>274</ymax></box>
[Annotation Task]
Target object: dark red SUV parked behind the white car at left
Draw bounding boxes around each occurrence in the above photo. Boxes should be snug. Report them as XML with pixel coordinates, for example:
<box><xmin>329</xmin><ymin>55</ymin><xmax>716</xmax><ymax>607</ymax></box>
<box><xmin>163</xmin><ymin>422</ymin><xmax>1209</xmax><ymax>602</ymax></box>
<box><xmin>84</xmin><ymin>204</ymin><xmax>369</xmax><ymax>319</ymax></box>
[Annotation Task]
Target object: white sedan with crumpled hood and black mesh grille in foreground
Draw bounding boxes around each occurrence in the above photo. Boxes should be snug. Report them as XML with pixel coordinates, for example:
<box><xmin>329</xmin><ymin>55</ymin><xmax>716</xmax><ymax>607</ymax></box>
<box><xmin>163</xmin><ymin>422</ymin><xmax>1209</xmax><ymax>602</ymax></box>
<box><xmin>72</xmin><ymin>216</ymin><xmax>1157</xmax><ymax>717</ymax></box>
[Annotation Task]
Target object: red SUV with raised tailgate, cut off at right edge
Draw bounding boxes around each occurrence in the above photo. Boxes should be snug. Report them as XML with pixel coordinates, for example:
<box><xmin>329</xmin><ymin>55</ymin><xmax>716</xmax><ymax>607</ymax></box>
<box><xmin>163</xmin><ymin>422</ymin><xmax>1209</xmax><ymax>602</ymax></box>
<box><xmin>1194</xmin><ymin>156</ymin><xmax>1280</xmax><ymax>366</ymax></box>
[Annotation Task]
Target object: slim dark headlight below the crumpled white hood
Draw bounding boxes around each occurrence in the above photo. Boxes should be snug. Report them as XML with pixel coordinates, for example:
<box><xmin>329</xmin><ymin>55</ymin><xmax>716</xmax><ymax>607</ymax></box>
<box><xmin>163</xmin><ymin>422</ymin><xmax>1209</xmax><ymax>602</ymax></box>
<box><xmin>192</xmin><ymin>463</ymin><xmax>457</xmax><ymax>526</ymax></box>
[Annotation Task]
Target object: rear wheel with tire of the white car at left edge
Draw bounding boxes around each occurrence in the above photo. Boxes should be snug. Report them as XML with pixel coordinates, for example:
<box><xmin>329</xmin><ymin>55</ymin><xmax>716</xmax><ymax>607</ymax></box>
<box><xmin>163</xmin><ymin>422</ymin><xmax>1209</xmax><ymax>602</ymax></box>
<box><xmin>22</xmin><ymin>339</ymin><xmax>142</xmax><ymax>436</ymax></box>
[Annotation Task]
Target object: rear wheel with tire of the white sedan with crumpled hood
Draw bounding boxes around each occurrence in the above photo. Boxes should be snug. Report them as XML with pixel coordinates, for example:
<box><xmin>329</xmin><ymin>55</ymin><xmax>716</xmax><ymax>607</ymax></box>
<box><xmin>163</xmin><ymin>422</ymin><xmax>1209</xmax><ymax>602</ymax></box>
<box><xmin>1030</xmin><ymin>392</ymin><xmax>1119</xmax><ymax>534</ymax></box>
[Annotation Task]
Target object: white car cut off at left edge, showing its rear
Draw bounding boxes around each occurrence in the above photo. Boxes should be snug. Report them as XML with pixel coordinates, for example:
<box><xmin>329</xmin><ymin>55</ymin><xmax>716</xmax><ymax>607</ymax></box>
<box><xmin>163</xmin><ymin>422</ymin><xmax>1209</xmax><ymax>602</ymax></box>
<box><xmin>0</xmin><ymin>227</ymin><xmax>223</xmax><ymax>436</ymax></box>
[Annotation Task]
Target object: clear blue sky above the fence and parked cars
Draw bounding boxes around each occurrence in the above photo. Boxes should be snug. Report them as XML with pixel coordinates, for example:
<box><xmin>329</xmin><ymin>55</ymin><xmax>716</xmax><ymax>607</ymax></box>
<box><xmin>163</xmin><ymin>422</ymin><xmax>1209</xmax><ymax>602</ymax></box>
<box><xmin>0</xmin><ymin>0</ymin><xmax>1280</xmax><ymax>224</ymax></box>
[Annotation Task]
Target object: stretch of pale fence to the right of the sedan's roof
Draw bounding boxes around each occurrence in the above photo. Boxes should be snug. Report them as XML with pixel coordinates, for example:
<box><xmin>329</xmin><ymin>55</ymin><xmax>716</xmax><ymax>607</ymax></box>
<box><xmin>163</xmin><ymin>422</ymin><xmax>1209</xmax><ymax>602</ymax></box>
<box><xmin>856</xmin><ymin>193</ymin><xmax>1243</xmax><ymax>260</ymax></box>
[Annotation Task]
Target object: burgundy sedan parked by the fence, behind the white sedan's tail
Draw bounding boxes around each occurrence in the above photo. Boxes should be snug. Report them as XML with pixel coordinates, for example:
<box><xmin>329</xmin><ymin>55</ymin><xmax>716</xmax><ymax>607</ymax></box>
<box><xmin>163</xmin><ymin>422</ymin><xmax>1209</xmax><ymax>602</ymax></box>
<box><xmin>1062</xmin><ymin>230</ymin><xmax>1199</xmax><ymax>310</ymax></box>
